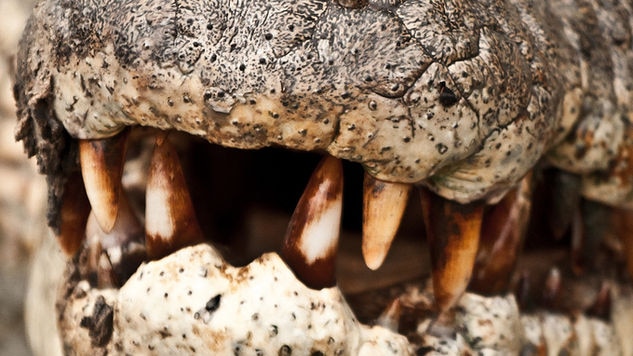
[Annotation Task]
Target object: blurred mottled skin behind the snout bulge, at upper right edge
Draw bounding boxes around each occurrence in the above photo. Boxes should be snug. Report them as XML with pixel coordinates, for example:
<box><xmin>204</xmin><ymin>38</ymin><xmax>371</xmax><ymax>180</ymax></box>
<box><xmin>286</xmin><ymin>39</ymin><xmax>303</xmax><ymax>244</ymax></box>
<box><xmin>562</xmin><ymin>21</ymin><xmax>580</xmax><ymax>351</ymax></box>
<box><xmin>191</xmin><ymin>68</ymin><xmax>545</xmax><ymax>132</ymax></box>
<box><xmin>550</xmin><ymin>0</ymin><xmax>633</xmax><ymax>209</ymax></box>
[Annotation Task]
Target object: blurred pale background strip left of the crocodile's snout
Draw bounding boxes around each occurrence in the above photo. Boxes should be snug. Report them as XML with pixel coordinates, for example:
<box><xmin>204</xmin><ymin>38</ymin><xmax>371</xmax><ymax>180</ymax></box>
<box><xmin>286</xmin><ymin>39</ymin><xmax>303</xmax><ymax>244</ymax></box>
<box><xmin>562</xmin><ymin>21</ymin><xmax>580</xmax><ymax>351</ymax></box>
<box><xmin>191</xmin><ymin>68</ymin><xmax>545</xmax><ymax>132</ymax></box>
<box><xmin>0</xmin><ymin>0</ymin><xmax>43</xmax><ymax>356</ymax></box>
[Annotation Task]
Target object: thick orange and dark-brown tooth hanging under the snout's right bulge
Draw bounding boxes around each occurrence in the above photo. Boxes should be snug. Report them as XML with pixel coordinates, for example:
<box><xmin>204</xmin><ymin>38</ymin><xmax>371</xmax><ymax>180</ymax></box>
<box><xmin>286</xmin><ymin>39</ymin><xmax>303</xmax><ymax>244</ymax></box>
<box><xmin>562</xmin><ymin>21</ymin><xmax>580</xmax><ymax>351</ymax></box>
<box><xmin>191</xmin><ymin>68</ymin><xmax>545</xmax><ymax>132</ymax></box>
<box><xmin>421</xmin><ymin>190</ymin><xmax>484</xmax><ymax>313</ymax></box>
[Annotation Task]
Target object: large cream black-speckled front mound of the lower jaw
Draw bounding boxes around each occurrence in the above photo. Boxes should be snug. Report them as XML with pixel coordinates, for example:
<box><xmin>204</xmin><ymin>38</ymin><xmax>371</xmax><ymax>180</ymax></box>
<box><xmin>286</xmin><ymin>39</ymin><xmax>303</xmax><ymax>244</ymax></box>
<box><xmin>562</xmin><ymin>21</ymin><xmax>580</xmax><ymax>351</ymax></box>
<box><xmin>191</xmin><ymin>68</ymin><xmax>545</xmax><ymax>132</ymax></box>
<box><xmin>58</xmin><ymin>245</ymin><xmax>413</xmax><ymax>356</ymax></box>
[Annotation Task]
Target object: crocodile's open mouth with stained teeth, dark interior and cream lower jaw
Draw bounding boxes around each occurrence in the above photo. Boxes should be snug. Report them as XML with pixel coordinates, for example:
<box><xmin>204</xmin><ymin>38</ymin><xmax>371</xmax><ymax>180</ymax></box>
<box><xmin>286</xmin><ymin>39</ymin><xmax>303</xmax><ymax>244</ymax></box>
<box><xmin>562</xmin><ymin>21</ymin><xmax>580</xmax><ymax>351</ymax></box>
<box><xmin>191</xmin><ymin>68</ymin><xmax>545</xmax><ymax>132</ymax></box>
<box><xmin>40</xmin><ymin>127</ymin><xmax>630</xmax><ymax>354</ymax></box>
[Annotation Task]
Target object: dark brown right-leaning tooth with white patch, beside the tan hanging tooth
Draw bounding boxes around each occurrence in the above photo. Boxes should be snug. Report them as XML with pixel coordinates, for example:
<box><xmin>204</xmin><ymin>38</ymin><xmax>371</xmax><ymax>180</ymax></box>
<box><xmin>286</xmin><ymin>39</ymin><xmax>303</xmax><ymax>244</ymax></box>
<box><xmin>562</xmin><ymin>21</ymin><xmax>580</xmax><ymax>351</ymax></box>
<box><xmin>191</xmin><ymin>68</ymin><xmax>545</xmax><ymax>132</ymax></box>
<box><xmin>281</xmin><ymin>156</ymin><xmax>343</xmax><ymax>289</ymax></box>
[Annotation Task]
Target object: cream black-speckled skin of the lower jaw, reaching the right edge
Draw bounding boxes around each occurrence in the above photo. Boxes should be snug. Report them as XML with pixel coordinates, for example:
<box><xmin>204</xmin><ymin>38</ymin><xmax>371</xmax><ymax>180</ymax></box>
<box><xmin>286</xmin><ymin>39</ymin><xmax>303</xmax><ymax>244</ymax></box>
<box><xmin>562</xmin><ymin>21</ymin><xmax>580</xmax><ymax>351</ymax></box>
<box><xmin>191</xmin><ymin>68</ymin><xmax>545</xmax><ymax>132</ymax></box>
<box><xmin>55</xmin><ymin>244</ymin><xmax>633</xmax><ymax>356</ymax></box>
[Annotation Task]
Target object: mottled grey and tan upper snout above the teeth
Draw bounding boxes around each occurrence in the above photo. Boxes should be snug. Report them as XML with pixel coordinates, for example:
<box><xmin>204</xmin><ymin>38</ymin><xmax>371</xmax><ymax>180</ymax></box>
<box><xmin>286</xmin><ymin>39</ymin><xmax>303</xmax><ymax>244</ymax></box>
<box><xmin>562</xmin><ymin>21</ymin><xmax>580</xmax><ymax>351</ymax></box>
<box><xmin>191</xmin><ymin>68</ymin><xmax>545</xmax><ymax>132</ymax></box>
<box><xmin>16</xmin><ymin>0</ymin><xmax>632</xmax><ymax>225</ymax></box>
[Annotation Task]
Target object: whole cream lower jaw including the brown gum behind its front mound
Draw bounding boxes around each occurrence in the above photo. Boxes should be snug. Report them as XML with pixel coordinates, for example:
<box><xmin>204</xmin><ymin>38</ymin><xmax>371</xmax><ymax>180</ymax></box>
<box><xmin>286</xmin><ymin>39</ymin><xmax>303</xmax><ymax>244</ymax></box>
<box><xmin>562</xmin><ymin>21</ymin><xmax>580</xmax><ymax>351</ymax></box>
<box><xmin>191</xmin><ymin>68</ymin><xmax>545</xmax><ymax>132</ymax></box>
<box><xmin>48</xmin><ymin>243</ymin><xmax>633</xmax><ymax>355</ymax></box>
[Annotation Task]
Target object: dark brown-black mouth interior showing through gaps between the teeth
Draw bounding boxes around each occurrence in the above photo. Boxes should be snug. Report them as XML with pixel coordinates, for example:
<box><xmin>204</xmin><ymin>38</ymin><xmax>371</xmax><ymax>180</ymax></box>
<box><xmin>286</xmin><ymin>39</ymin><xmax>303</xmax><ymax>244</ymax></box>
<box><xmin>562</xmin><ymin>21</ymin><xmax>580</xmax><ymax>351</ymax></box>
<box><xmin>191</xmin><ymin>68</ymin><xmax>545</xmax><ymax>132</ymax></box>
<box><xmin>97</xmin><ymin>128</ymin><xmax>624</xmax><ymax>331</ymax></box>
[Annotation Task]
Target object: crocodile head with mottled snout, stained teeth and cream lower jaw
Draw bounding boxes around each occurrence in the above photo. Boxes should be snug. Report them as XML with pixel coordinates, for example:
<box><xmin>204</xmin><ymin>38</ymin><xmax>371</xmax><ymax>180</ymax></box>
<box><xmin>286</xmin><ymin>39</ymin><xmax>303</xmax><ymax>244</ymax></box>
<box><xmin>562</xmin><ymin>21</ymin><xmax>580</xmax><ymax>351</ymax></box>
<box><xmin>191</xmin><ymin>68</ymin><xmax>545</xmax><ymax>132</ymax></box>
<box><xmin>15</xmin><ymin>0</ymin><xmax>633</xmax><ymax>354</ymax></box>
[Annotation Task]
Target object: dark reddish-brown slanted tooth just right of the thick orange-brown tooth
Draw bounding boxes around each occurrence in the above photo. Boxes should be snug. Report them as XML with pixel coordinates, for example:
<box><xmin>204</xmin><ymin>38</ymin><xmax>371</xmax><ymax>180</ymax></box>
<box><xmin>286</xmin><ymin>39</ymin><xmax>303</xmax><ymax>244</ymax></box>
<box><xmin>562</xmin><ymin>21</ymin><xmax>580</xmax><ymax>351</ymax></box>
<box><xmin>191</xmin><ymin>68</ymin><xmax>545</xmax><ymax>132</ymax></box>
<box><xmin>469</xmin><ymin>176</ymin><xmax>531</xmax><ymax>295</ymax></box>
